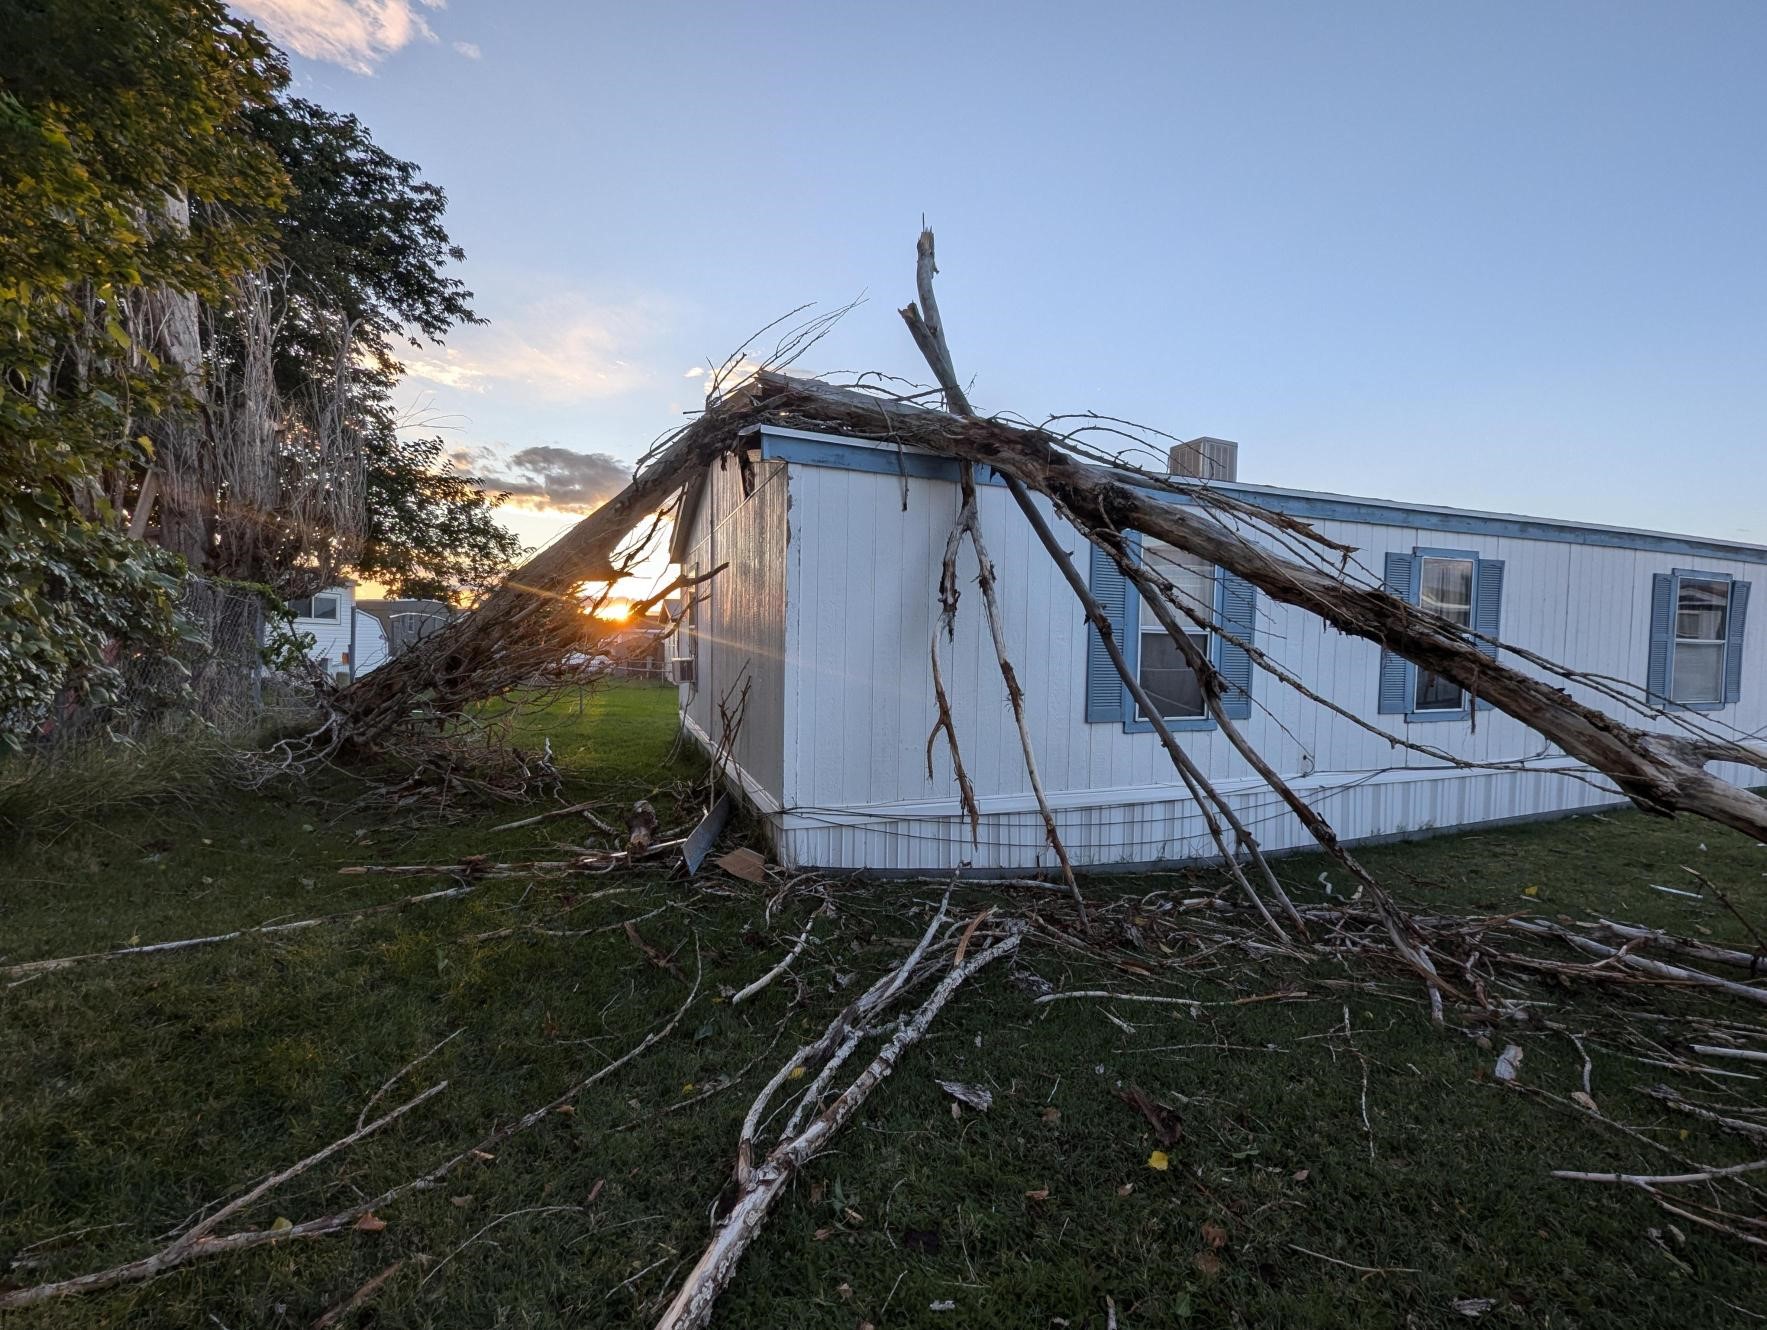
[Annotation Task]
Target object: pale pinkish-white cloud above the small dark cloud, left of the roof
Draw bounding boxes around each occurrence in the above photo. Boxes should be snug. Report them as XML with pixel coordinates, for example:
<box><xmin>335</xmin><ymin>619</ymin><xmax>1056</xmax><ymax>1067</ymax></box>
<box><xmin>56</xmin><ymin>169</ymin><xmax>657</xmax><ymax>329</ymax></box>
<box><xmin>405</xmin><ymin>297</ymin><xmax>668</xmax><ymax>403</ymax></box>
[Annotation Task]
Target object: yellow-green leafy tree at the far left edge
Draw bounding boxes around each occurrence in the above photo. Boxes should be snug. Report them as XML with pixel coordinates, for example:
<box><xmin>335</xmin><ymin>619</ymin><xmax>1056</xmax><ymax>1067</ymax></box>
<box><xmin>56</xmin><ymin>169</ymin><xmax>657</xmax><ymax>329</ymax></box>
<box><xmin>0</xmin><ymin>0</ymin><xmax>286</xmax><ymax>742</ymax></box>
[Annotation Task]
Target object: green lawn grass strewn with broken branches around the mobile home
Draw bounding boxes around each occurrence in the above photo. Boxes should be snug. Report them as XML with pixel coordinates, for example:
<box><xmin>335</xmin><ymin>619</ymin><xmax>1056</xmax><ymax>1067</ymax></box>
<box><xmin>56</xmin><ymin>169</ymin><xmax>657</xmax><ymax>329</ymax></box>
<box><xmin>0</xmin><ymin>685</ymin><xmax>1767</xmax><ymax>1330</ymax></box>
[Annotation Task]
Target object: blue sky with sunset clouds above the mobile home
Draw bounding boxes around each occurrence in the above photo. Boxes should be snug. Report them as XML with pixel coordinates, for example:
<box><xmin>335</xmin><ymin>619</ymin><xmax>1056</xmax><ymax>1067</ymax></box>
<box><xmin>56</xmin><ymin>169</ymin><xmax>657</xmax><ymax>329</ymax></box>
<box><xmin>233</xmin><ymin>0</ymin><xmax>1767</xmax><ymax>582</ymax></box>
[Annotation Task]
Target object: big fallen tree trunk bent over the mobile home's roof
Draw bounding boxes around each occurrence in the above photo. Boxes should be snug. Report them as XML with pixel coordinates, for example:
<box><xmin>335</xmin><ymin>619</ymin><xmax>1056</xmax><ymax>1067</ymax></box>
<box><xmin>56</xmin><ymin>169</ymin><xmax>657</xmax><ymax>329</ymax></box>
<box><xmin>334</xmin><ymin>261</ymin><xmax>1767</xmax><ymax>839</ymax></box>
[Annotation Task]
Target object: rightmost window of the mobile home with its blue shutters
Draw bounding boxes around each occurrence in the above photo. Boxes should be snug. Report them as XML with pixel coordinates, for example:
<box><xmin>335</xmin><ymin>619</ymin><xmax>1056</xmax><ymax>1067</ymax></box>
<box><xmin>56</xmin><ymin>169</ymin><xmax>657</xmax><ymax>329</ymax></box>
<box><xmin>1645</xmin><ymin>569</ymin><xmax>1749</xmax><ymax>712</ymax></box>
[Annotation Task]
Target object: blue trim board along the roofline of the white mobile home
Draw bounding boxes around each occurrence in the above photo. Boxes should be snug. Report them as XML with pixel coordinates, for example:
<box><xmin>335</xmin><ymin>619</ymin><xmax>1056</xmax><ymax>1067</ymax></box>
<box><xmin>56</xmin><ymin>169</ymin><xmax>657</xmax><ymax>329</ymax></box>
<box><xmin>756</xmin><ymin>426</ymin><xmax>1767</xmax><ymax>563</ymax></box>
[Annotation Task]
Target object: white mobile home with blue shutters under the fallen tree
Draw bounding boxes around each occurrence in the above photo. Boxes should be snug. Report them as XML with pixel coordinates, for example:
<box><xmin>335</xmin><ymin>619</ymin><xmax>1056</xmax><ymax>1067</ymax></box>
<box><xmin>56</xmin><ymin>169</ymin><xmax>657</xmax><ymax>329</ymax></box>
<box><xmin>675</xmin><ymin>426</ymin><xmax>1767</xmax><ymax>873</ymax></box>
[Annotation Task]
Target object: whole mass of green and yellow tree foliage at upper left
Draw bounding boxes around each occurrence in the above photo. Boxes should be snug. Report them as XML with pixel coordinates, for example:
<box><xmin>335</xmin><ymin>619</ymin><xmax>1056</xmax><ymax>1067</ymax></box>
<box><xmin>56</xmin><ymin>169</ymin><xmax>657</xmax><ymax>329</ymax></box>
<box><xmin>0</xmin><ymin>0</ymin><xmax>518</xmax><ymax>742</ymax></box>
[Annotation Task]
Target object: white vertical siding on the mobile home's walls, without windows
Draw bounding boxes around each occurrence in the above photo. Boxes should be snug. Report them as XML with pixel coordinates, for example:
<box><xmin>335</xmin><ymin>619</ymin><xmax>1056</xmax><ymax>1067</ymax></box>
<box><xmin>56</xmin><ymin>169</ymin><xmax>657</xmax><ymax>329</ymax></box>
<box><xmin>756</xmin><ymin>465</ymin><xmax>1767</xmax><ymax>869</ymax></box>
